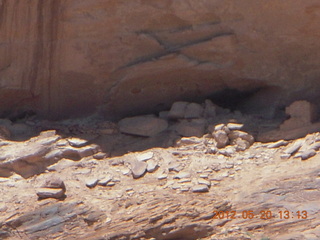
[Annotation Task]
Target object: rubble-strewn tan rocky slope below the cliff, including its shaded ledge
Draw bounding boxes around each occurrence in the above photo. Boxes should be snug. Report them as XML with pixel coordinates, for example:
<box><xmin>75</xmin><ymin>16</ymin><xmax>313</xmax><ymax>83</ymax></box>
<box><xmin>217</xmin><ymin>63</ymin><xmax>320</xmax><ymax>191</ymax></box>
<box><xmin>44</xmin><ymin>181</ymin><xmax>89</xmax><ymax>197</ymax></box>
<box><xmin>0</xmin><ymin>101</ymin><xmax>320</xmax><ymax>240</ymax></box>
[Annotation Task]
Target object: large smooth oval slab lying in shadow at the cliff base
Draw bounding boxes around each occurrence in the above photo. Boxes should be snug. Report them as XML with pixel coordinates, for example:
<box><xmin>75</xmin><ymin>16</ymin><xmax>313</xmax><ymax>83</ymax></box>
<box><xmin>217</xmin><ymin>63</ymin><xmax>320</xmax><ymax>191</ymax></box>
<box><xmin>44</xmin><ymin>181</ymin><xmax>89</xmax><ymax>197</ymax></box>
<box><xmin>119</xmin><ymin>116</ymin><xmax>168</xmax><ymax>137</ymax></box>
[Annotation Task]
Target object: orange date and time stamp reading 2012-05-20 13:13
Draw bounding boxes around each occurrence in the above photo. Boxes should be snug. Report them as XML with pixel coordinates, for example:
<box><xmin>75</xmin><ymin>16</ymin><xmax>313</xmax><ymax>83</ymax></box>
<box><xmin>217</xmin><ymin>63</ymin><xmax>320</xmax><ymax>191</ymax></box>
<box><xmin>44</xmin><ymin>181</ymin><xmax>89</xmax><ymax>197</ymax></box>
<box><xmin>213</xmin><ymin>210</ymin><xmax>308</xmax><ymax>220</ymax></box>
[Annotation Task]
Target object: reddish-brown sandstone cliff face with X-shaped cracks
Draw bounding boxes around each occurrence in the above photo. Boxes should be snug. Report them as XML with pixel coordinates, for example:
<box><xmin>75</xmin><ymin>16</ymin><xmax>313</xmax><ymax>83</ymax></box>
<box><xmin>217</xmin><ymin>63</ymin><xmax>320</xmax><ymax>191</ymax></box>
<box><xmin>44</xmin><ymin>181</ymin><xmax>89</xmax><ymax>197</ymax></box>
<box><xmin>0</xmin><ymin>0</ymin><xmax>320</xmax><ymax>118</ymax></box>
